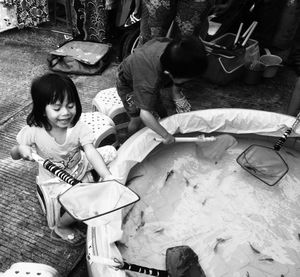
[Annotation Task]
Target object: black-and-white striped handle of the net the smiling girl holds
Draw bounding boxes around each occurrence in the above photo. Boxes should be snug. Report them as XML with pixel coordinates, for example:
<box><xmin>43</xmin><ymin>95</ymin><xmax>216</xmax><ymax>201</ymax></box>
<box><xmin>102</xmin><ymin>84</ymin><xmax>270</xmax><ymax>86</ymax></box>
<box><xmin>32</xmin><ymin>153</ymin><xmax>80</xmax><ymax>186</ymax></box>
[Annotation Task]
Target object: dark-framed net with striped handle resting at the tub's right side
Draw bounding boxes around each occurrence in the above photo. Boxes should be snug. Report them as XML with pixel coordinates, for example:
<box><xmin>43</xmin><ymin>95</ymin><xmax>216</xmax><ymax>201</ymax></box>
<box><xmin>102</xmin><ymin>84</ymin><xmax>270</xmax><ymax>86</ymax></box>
<box><xmin>236</xmin><ymin>113</ymin><xmax>300</xmax><ymax>186</ymax></box>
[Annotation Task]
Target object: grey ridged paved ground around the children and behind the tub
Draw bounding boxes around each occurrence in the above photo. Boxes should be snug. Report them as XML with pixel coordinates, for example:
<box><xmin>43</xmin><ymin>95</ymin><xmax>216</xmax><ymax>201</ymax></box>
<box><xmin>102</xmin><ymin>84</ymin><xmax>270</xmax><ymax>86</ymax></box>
<box><xmin>0</xmin><ymin>20</ymin><xmax>295</xmax><ymax>276</ymax></box>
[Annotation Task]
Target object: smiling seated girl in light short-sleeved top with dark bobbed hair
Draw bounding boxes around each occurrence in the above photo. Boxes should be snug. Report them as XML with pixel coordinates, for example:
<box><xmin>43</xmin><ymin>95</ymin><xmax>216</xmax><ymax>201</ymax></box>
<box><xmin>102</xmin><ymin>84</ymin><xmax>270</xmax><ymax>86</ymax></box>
<box><xmin>11</xmin><ymin>73</ymin><xmax>116</xmax><ymax>243</ymax></box>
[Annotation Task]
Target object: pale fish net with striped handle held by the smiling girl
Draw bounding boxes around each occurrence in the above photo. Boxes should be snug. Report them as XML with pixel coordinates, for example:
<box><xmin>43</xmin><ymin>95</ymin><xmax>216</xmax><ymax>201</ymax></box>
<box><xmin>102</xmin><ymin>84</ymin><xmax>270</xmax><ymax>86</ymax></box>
<box><xmin>32</xmin><ymin>153</ymin><xmax>139</xmax><ymax>222</ymax></box>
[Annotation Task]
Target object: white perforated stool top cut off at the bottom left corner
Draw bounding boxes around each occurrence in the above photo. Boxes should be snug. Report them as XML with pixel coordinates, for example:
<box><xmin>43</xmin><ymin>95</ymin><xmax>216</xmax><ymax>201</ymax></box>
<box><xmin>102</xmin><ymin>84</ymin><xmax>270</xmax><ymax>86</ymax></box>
<box><xmin>2</xmin><ymin>262</ymin><xmax>61</xmax><ymax>277</ymax></box>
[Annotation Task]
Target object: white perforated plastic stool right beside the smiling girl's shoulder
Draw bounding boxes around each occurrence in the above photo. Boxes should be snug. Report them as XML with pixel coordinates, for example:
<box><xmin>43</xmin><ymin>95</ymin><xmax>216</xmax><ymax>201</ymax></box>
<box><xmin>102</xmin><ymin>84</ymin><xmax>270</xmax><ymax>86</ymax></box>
<box><xmin>80</xmin><ymin>112</ymin><xmax>119</xmax><ymax>147</ymax></box>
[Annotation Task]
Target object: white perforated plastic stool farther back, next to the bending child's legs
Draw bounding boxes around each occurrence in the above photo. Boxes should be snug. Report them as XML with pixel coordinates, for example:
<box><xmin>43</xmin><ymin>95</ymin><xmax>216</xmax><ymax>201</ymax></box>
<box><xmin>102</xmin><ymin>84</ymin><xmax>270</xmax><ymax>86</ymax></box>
<box><xmin>92</xmin><ymin>87</ymin><xmax>129</xmax><ymax>129</ymax></box>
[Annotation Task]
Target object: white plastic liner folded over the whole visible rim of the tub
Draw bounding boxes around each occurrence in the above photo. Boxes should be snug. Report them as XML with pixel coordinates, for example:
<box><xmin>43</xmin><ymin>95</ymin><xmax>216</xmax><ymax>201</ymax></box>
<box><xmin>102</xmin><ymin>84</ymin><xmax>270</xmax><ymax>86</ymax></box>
<box><xmin>87</xmin><ymin>109</ymin><xmax>300</xmax><ymax>277</ymax></box>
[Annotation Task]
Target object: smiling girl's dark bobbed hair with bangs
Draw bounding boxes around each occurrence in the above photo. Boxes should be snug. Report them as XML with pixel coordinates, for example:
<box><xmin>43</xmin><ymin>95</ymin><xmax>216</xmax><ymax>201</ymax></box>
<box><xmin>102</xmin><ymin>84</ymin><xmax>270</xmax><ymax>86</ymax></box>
<box><xmin>27</xmin><ymin>73</ymin><xmax>82</xmax><ymax>130</ymax></box>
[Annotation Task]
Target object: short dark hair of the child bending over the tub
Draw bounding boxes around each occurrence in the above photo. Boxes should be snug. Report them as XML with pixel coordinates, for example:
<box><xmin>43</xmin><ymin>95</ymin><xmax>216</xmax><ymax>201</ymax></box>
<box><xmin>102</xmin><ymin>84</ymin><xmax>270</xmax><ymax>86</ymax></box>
<box><xmin>160</xmin><ymin>36</ymin><xmax>207</xmax><ymax>78</ymax></box>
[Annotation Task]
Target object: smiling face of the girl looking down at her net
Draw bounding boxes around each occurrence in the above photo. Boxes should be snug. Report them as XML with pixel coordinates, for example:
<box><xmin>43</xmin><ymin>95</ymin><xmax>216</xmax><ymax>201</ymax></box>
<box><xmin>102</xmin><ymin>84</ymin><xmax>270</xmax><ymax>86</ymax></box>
<box><xmin>45</xmin><ymin>97</ymin><xmax>76</xmax><ymax>129</ymax></box>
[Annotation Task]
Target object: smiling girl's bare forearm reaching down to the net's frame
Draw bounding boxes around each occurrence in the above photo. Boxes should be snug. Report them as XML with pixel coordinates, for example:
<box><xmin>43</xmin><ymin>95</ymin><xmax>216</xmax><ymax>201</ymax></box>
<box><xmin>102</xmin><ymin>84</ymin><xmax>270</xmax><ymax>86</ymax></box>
<box><xmin>83</xmin><ymin>143</ymin><xmax>111</xmax><ymax>179</ymax></box>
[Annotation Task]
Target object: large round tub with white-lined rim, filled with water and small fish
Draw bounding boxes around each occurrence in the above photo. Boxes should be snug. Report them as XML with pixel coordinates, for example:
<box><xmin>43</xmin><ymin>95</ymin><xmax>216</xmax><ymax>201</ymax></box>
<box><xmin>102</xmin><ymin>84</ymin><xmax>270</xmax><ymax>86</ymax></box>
<box><xmin>87</xmin><ymin>109</ymin><xmax>300</xmax><ymax>277</ymax></box>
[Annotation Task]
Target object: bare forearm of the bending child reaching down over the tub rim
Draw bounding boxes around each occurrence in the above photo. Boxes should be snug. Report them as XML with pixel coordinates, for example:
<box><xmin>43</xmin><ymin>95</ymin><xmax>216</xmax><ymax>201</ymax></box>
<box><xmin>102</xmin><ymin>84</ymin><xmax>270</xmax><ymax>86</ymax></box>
<box><xmin>140</xmin><ymin>109</ymin><xmax>175</xmax><ymax>144</ymax></box>
